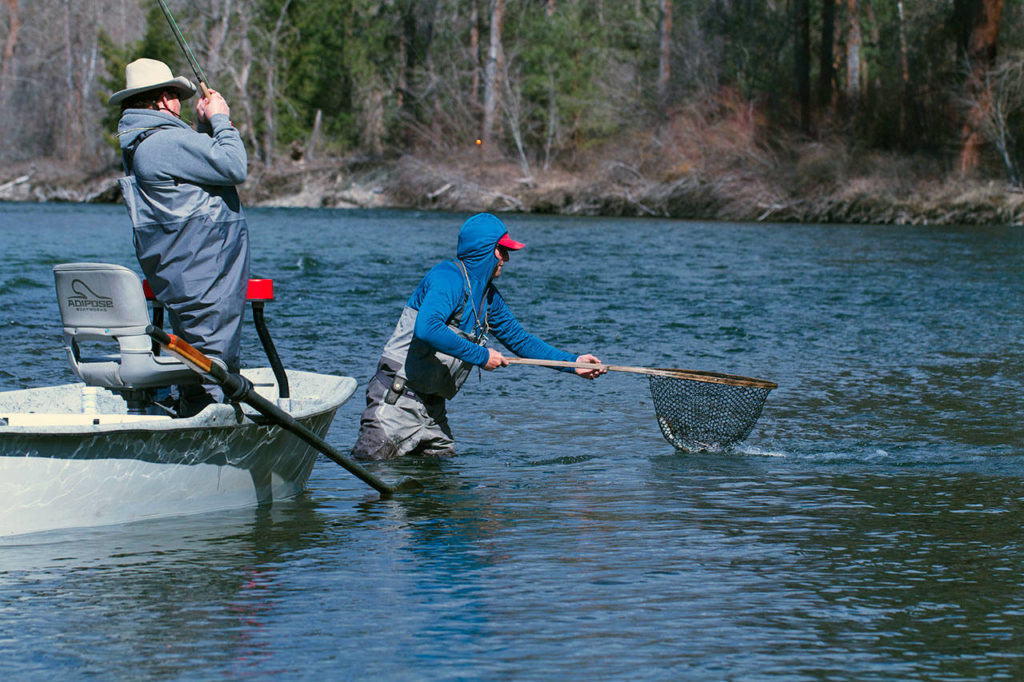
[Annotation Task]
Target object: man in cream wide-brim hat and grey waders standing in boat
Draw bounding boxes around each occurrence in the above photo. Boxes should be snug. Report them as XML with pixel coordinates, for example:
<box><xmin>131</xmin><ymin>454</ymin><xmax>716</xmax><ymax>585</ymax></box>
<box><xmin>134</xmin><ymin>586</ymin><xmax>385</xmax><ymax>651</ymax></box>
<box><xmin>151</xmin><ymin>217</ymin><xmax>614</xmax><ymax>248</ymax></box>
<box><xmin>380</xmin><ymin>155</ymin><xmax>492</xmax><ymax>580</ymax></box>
<box><xmin>110</xmin><ymin>58</ymin><xmax>249</xmax><ymax>416</ymax></box>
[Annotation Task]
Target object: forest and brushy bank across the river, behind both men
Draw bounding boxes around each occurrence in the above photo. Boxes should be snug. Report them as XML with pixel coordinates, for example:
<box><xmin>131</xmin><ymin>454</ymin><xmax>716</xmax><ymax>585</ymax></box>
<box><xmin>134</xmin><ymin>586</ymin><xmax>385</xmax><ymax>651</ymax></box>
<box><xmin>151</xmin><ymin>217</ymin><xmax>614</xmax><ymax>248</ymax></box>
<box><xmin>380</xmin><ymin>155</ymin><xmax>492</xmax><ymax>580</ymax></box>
<box><xmin>0</xmin><ymin>0</ymin><xmax>1024</xmax><ymax>224</ymax></box>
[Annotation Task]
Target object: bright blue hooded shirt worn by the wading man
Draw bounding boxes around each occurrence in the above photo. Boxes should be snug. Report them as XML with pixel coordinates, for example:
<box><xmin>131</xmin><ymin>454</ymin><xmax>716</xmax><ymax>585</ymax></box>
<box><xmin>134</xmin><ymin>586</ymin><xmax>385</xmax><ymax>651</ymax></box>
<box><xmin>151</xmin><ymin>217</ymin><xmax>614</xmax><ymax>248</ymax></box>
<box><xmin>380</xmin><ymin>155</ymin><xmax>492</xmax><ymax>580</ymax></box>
<box><xmin>408</xmin><ymin>213</ymin><xmax>575</xmax><ymax>367</ymax></box>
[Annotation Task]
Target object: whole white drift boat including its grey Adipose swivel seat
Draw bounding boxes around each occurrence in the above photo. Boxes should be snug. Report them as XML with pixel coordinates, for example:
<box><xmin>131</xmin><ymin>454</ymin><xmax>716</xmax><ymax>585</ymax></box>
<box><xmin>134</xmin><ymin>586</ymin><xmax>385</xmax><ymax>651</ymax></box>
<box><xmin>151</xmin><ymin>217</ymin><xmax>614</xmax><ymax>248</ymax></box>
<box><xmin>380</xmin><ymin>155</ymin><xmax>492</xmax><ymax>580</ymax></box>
<box><xmin>0</xmin><ymin>263</ymin><xmax>356</xmax><ymax>537</ymax></box>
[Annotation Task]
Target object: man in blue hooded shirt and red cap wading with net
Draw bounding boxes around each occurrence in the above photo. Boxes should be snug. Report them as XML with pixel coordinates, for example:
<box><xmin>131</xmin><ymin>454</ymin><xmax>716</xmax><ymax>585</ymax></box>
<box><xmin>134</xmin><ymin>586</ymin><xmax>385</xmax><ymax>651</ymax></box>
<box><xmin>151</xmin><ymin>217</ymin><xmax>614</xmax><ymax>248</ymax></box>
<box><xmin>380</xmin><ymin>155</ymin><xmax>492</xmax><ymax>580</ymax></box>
<box><xmin>352</xmin><ymin>213</ymin><xmax>605</xmax><ymax>460</ymax></box>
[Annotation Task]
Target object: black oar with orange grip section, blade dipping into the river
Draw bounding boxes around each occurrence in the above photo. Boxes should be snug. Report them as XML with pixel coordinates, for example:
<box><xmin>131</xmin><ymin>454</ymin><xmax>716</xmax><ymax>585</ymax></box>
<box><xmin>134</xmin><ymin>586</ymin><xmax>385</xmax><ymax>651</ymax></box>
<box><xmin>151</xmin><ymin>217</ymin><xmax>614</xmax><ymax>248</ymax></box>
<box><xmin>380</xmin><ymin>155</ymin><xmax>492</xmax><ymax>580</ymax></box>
<box><xmin>146</xmin><ymin>325</ymin><xmax>423</xmax><ymax>497</ymax></box>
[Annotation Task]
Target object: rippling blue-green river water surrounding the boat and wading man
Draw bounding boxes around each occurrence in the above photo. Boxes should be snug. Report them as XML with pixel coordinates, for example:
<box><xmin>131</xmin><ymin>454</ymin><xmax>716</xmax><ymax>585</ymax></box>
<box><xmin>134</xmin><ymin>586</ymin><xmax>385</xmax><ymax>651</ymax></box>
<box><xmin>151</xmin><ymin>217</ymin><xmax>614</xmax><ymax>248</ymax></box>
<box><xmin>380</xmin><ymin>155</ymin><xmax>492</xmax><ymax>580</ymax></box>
<box><xmin>0</xmin><ymin>204</ymin><xmax>1024</xmax><ymax>680</ymax></box>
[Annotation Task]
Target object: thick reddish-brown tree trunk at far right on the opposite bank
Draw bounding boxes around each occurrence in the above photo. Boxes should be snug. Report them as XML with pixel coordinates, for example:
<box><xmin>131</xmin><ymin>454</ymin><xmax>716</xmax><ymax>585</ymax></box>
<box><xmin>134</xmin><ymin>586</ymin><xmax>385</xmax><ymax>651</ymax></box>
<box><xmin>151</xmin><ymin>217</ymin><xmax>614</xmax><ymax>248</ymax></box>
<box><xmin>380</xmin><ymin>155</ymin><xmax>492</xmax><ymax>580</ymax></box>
<box><xmin>953</xmin><ymin>0</ymin><xmax>1002</xmax><ymax>175</ymax></box>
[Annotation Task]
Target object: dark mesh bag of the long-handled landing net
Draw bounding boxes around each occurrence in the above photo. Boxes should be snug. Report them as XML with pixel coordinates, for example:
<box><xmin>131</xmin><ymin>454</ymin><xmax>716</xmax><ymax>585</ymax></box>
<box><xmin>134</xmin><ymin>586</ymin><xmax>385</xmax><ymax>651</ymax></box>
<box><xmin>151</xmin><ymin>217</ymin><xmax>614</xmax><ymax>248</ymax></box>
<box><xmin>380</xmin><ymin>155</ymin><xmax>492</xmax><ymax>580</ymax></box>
<box><xmin>648</xmin><ymin>373</ymin><xmax>775</xmax><ymax>451</ymax></box>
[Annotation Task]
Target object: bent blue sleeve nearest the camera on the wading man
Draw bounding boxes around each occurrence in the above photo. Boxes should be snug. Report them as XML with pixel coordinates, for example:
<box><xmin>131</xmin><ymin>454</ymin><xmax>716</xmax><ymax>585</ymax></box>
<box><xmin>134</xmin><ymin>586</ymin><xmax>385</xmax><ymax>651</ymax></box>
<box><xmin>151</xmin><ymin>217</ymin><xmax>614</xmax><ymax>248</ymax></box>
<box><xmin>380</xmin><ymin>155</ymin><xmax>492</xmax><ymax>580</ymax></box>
<box><xmin>409</xmin><ymin>263</ymin><xmax>490</xmax><ymax>367</ymax></box>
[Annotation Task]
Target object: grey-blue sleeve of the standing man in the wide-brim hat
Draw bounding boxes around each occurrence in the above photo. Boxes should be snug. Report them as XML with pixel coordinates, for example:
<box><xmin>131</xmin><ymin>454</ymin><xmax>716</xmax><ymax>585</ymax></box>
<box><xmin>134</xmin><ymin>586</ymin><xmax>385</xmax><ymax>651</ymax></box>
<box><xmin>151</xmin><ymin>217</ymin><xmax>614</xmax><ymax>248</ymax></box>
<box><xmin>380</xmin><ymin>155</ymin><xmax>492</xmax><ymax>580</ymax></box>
<box><xmin>135</xmin><ymin>114</ymin><xmax>249</xmax><ymax>185</ymax></box>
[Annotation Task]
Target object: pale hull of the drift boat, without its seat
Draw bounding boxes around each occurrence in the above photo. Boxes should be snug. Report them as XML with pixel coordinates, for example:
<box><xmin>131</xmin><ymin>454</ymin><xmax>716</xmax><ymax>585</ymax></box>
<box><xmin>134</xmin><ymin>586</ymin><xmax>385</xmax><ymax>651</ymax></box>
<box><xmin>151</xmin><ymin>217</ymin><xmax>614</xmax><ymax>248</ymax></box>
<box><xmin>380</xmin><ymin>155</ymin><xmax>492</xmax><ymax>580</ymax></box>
<box><xmin>0</xmin><ymin>370</ymin><xmax>355</xmax><ymax>536</ymax></box>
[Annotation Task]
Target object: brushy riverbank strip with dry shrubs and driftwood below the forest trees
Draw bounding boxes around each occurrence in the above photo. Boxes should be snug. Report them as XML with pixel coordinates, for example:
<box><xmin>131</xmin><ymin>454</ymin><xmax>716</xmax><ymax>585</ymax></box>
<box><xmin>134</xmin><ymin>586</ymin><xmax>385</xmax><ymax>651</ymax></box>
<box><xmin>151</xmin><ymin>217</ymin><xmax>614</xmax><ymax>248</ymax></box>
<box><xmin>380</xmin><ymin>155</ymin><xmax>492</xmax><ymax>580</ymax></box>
<box><xmin>0</xmin><ymin>145</ymin><xmax>1024</xmax><ymax>225</ymax></box>
